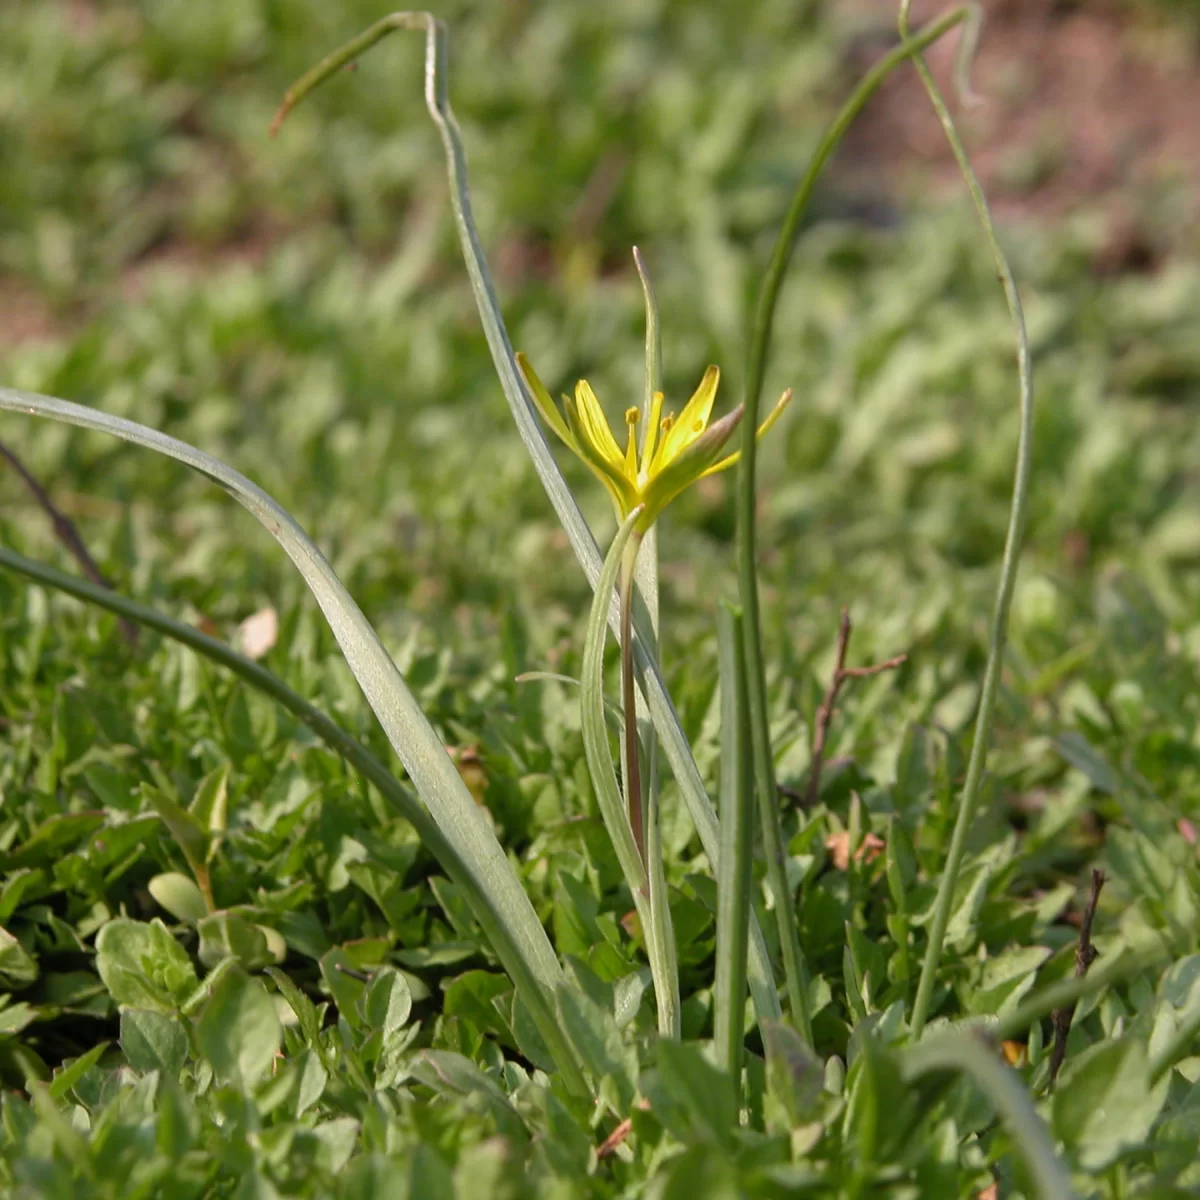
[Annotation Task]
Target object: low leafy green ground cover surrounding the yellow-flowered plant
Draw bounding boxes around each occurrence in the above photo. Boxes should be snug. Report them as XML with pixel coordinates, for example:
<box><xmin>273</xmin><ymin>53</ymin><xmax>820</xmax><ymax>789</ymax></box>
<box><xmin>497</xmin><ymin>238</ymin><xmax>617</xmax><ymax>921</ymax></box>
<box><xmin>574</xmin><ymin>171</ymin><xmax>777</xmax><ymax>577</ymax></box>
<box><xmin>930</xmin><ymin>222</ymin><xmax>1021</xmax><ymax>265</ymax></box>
<box><xmin>0</xmin><ymin>0</ymin><xmax>1200</xmax><ymax>1198</ymax></box>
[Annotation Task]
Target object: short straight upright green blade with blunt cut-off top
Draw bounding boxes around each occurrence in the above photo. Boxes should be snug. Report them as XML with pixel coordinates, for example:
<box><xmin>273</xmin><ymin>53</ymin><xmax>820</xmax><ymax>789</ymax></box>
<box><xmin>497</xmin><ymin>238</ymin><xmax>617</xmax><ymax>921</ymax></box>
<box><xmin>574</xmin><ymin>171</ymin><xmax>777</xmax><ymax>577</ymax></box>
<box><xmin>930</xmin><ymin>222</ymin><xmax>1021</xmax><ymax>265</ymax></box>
<box><xmin>713</xmin><ymin>602</ymin><xmax>754</xmax><ymax>1106</ymax></box>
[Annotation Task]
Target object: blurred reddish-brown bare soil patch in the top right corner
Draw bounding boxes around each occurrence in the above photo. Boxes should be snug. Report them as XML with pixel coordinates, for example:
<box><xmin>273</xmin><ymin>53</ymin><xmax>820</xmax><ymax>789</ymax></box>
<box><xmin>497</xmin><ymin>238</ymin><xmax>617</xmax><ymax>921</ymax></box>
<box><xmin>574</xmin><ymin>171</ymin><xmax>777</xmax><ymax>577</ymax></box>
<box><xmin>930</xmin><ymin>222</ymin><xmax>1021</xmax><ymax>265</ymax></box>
<box><xmin>842</xmin><ymin>0</ymin><xmax>1200</xmax><ymax>253</ymax></box>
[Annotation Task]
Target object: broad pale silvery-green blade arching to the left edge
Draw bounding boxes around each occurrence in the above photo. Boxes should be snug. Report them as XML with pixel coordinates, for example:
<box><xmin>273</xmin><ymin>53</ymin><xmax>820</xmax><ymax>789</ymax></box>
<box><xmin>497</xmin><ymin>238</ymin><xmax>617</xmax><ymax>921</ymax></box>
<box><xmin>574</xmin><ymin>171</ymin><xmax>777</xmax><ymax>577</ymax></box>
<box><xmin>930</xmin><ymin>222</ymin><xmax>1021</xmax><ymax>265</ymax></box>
<box><xmin>0</xmin><ymin>388</ymin><xmax>582</xmax><ymax>1099</ymax></box>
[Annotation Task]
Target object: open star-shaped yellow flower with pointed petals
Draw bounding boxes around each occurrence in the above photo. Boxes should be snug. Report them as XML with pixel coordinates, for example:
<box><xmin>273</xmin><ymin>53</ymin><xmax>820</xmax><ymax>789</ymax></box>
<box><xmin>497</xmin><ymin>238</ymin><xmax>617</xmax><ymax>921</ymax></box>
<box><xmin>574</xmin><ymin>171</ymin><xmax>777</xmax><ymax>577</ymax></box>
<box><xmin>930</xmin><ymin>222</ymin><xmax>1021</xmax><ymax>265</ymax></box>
<box><xmin>517</xmin><ymin>354</ymin><xmax>792</xmax><ymax>534</ymax></box>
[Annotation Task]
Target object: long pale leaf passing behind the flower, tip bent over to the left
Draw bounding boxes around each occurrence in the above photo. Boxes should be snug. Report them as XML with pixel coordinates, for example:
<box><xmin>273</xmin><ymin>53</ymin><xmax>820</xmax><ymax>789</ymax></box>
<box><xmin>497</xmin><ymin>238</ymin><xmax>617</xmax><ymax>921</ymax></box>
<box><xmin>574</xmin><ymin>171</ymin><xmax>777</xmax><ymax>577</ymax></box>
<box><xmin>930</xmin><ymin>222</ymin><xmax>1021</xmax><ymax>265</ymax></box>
<box><xmin>276</xmin><ymin>12</ymin><xmax>780</xmax><ymax>1018</ymax></box>
